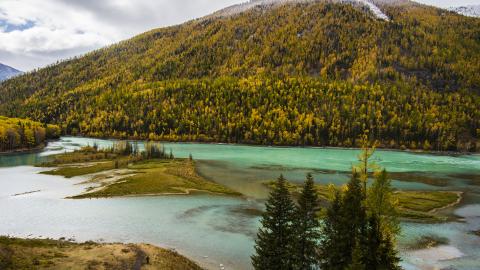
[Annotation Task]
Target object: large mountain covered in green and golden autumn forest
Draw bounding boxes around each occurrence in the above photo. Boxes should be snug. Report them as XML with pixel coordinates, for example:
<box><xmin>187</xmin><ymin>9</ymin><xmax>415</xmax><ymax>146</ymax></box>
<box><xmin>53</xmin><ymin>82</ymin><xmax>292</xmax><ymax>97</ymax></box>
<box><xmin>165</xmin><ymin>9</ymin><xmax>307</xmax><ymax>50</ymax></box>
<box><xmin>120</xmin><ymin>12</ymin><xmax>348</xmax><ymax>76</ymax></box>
<box><xmin>0</xmin><ymin>0</ymin><xmax>480</xmax><ymax>151</ymax></box>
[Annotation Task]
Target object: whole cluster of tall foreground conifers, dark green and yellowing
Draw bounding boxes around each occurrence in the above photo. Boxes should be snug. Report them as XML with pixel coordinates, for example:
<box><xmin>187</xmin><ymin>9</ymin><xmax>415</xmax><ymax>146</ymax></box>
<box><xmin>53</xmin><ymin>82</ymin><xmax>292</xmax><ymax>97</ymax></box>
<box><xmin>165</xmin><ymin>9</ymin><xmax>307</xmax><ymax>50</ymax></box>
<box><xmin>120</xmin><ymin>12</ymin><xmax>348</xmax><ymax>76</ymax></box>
<box><xmin>252</xmin><ymin>142</ymin><xmax>433</xmax><ymax>270</ymax></box>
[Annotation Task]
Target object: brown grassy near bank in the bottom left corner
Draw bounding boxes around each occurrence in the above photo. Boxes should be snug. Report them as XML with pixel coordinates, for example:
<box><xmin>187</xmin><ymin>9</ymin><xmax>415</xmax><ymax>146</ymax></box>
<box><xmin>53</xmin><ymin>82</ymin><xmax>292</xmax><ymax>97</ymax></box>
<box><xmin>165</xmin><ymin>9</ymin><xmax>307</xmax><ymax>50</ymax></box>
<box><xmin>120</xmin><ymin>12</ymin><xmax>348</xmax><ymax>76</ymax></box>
<box><xmin>0</xmin><ymin>236</ymin><xmax>201</xmax><ymax>270</ymax></box>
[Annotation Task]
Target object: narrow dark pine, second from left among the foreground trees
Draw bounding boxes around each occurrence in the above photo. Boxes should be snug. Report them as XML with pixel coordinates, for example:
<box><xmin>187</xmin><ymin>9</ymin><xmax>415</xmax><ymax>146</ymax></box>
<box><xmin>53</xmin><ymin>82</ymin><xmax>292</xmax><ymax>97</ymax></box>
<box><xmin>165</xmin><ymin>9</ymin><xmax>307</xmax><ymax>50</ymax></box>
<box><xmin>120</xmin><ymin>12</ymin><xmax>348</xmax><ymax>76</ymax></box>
<box><xmin>294</xmin><ymin>173</ymin><xmax>320</xmax><ymax>270</ymax></box>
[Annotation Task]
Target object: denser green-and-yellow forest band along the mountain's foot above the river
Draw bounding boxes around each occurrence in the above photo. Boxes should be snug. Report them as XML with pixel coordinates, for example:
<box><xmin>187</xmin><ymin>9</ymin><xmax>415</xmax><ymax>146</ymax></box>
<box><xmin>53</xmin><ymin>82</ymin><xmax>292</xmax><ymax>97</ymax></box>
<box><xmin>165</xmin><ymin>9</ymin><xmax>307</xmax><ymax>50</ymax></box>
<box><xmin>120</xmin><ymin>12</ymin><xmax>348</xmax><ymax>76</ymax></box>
<box><xmin>12</xmin><ymin>77</ymin><xmax>480</xmax><ymax>151</ymax></box>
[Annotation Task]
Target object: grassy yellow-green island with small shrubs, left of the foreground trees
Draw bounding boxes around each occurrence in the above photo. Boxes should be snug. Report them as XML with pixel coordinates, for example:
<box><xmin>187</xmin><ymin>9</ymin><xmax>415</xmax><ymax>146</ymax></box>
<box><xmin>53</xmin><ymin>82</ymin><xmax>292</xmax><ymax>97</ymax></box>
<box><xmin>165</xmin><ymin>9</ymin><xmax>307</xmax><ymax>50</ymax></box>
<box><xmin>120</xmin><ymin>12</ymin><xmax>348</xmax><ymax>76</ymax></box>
<box><xmin>42</xmin><ymin>142</ymin><xmax>240</xmax><ymax>199</ymax></box>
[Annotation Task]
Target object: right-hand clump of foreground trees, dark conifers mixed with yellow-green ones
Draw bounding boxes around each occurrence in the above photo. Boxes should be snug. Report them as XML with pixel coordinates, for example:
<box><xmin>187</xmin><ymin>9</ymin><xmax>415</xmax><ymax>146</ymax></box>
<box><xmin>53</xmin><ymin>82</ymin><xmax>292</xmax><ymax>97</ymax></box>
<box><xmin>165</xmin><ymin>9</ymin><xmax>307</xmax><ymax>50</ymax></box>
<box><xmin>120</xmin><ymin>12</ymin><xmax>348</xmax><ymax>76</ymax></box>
<box><xmin>320</xmin><ymin>147</ymin><xmax>401</xmax><ymax>270</ymax></box>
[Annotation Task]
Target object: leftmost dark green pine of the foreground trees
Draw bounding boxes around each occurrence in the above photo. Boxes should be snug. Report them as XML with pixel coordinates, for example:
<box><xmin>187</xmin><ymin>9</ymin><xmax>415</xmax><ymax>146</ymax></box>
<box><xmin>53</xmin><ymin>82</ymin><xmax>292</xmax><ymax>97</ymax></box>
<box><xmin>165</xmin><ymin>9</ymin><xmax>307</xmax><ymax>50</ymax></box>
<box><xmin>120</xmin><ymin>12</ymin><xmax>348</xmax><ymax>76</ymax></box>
<box><xmin>252</xmin><ymin>175</ymin><xmax>295</xmax><ymax>270</ymax></box>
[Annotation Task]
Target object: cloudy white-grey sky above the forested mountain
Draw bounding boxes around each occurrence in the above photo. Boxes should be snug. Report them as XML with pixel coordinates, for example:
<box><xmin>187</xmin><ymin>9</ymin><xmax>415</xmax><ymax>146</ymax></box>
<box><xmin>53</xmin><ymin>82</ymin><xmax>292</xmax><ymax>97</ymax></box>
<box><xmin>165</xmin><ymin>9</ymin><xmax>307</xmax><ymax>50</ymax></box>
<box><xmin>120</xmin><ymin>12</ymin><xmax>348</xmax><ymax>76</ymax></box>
<box><xmin>0</xmin><ymin>0</ymin><xmax>480</xmax><ymax>71</ymax></box>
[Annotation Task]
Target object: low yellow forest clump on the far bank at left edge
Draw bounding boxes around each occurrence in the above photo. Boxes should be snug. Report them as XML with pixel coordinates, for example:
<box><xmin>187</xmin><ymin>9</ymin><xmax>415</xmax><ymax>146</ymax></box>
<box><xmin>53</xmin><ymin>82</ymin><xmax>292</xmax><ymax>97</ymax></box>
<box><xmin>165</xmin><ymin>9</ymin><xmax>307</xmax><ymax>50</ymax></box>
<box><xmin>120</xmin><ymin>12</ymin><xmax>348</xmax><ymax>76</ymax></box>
<box><xmin>0</xmin><ymin>116</ymin><xmax>61</xmax><ymax>152</ymax></box>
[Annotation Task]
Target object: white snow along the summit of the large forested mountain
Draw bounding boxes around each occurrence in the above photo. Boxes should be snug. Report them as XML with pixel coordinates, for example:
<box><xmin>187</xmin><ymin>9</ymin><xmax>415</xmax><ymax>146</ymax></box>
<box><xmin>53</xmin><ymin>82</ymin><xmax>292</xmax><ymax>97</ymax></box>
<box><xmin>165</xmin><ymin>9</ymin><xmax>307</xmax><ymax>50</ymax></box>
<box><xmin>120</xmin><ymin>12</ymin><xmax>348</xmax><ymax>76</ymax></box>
<box><xmin>213</xmin><ymin>0</ymin><xmax>389</xmax><ymax>20</ymax></box>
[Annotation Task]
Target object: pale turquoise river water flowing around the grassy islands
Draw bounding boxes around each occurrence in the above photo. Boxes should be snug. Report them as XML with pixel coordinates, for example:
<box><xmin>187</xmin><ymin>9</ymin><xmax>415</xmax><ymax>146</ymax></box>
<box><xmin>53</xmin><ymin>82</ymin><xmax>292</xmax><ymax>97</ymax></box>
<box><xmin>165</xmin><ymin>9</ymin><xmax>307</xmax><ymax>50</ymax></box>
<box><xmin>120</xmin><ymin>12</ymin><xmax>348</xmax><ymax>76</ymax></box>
<box><xmin>0</xmin><ymin>137</ymin><xmax>480</xmax><ymax>269</ymax></box>
